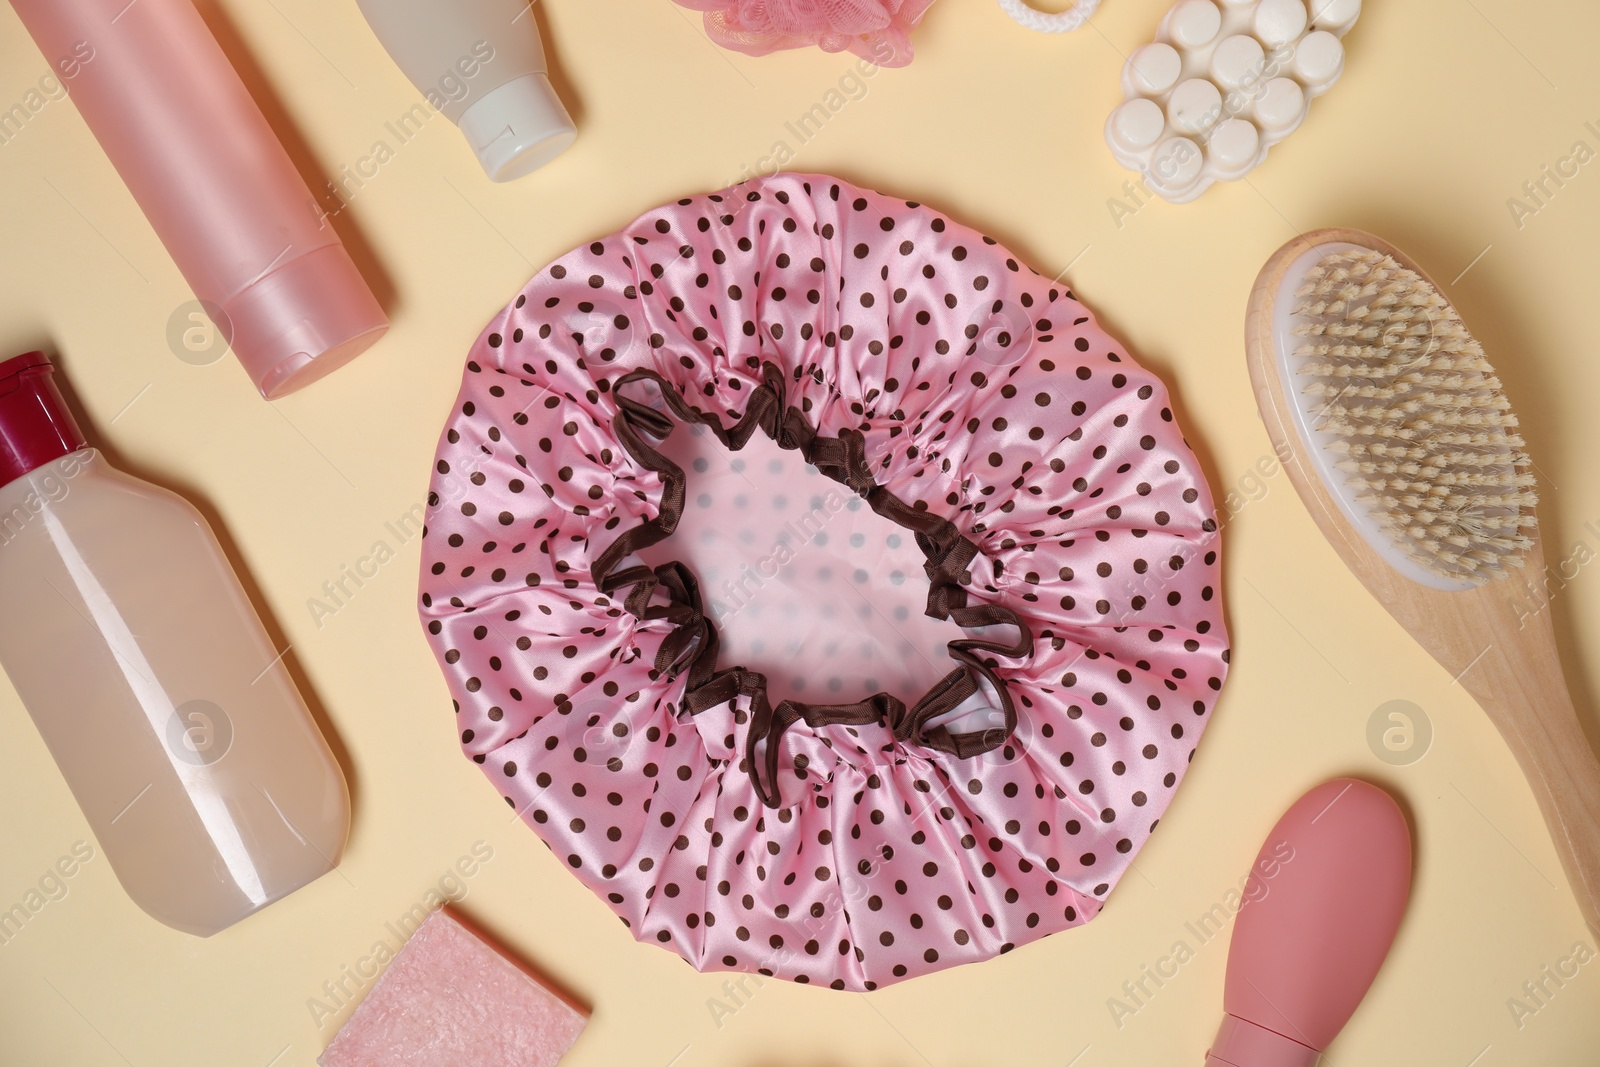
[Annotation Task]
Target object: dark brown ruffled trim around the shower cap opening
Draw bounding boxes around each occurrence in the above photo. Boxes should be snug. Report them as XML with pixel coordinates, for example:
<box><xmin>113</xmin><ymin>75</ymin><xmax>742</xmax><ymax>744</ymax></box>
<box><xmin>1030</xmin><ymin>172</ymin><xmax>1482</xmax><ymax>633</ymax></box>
<box><xmin>592</xmin><ymin>363</ymin><xmax>1034</xmax><ymax>808</ymax></box>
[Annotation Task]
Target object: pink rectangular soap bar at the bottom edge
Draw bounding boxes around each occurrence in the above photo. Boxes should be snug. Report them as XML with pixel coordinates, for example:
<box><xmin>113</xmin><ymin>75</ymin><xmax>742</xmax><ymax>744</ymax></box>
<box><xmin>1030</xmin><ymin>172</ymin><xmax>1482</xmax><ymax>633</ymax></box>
<box><xmin>317</xmin><ymin>910</ymin><xmax>589</xmax><ymax>1067</ymax></box>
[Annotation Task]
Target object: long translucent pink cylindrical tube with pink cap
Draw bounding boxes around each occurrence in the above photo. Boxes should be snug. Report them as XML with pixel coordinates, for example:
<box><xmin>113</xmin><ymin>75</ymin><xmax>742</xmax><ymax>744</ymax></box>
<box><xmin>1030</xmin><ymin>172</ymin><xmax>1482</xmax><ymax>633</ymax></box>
<box><xmin>11</xmin><ymin>0</ymin><xmax>389</xmax><ymax>400</ymax></box>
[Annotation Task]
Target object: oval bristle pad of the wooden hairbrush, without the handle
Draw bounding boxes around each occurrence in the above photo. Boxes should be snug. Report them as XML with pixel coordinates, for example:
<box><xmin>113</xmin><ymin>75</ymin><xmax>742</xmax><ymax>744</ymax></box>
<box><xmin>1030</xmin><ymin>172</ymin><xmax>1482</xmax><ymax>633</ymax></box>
<box><xmin>1274</xmin><ymin>242</ymin><xmax>1536</xmax><ymax>590</ymax></box>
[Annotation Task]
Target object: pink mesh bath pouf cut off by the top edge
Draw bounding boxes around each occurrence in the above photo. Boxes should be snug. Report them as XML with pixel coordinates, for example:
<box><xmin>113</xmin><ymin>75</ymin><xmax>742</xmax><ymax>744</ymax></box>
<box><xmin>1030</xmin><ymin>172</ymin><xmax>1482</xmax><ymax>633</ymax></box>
<box><xmin>677</xmin><ymin>0</ymin><xmax>933</xmax><ymax>67</ymax></box>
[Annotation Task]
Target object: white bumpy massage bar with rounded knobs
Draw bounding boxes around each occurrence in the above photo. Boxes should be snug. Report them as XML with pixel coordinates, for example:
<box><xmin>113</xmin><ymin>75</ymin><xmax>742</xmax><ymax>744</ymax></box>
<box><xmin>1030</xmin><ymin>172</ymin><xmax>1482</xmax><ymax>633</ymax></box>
<box><xmin>1106</xmin><ymin>0</ymin><xmax>1362</xmax><ymax>203</ymax></box>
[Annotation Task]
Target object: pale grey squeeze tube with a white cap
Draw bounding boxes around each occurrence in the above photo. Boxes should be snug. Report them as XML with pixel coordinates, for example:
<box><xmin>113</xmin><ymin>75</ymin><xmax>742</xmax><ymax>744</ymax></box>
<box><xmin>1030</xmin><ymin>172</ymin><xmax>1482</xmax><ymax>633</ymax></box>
<box><xmin>357</xmin><ymin>0</ymin><xmax>578</xmax><ymax>181</ymax></box>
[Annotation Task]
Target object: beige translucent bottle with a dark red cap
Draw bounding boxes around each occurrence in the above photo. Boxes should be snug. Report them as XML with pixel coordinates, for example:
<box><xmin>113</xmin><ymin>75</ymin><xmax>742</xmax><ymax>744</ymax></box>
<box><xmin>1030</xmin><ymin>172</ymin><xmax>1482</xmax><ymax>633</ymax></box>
<box><xmin>0</xmin><ymin>352</ymin><xmax>350</xmax><ymax>936</ymax></box>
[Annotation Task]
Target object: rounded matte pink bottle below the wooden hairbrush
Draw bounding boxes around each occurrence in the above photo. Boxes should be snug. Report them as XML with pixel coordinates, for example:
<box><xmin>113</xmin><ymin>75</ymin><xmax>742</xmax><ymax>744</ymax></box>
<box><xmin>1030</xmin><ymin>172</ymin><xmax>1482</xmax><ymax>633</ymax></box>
<box><xmin>1206</xmin><ymin>777</ymin><xmax>1411</xmax><ymax>1067</ymax></box>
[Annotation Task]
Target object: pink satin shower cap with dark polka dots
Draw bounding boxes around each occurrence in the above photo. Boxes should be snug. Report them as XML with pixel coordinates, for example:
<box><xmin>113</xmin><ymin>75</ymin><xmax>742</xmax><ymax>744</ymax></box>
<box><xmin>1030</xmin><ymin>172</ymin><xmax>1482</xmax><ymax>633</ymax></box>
<box><xmin>421</xmin><ymin>174</ymin><xmax>1227</xmax><ymax>990</ymax></box>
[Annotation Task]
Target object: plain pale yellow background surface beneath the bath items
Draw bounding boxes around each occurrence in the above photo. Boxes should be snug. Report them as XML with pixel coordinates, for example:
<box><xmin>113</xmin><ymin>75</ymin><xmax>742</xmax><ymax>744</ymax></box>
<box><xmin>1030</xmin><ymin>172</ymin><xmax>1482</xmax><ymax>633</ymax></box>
<box><xmin>0</xmin><ymin>0</ymin><xmax>1600</xmax><ymax>1067</ymax></box>
